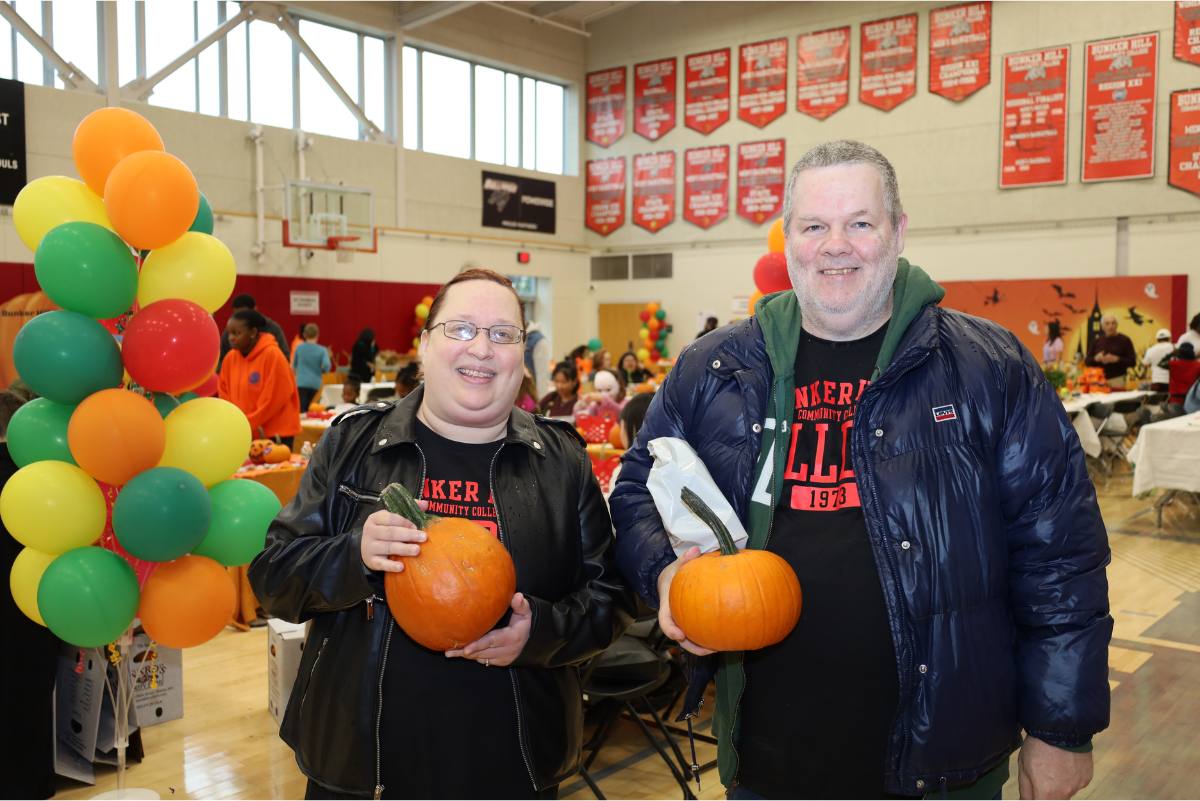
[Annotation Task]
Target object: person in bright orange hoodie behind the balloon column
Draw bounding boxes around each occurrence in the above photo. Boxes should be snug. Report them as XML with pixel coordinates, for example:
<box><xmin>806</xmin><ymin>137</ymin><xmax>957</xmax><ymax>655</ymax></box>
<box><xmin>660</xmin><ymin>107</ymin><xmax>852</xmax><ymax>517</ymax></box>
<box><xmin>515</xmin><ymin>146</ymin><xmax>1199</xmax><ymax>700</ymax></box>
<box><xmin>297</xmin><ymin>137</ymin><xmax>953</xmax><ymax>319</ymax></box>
<box><xmin>218</xmin><ymin>309</ymin><xmax>300</xmax><ymax>447</ymax></box>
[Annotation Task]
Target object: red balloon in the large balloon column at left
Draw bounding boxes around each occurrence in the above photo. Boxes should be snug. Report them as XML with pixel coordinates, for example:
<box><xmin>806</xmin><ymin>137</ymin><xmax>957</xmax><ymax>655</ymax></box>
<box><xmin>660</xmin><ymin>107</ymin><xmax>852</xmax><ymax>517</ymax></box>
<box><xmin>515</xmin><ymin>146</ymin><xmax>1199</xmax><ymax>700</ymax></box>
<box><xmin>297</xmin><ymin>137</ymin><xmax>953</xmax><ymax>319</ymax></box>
<box><xmin>121</xmin><ymin>299</ymin><xmax>221</xmax><ymax>395</ymax></box>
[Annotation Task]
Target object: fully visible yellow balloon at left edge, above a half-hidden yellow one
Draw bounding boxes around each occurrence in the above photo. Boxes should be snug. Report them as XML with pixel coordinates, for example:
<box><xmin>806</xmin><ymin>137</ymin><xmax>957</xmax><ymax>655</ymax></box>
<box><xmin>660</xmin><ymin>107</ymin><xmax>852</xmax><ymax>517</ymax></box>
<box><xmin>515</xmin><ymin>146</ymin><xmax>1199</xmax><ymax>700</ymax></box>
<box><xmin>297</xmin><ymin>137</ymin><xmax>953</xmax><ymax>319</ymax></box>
<box><xmin>0</xmin><ymin>462</ymin><xmax>107</xmax><ymax>554</ymax></box>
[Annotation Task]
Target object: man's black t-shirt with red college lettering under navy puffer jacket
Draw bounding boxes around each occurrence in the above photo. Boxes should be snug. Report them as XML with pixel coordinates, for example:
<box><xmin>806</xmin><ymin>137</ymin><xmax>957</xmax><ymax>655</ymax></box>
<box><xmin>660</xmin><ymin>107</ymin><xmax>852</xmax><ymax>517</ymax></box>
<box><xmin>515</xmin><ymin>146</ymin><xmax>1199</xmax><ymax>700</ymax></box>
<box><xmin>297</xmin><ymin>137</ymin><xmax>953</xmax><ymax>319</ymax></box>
<box><xmin>738</xmin><ymin>325</ymin><xmax>898</xmax><ymax>799</ymax></box>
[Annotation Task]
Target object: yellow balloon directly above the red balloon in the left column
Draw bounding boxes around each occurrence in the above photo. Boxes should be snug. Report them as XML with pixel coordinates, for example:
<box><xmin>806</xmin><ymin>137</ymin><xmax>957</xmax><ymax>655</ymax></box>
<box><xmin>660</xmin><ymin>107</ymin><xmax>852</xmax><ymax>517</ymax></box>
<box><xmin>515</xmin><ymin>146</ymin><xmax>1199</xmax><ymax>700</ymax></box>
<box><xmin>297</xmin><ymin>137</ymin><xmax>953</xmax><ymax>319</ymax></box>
<box><xmin>138</xmin><ymin>231</ymin><xmax>238</xmax><ymax>312</ymax></box>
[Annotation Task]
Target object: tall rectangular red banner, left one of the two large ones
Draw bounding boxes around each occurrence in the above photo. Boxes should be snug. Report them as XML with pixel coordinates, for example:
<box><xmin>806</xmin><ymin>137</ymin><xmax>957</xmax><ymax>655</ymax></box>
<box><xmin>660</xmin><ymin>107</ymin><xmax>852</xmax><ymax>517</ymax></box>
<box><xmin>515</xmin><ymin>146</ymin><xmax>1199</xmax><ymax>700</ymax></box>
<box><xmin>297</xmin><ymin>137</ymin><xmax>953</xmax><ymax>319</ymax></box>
<box><xmin>1000</xmin><ymin>44</ymin><xmax>1070</xmax><ymax>189</ymax></box>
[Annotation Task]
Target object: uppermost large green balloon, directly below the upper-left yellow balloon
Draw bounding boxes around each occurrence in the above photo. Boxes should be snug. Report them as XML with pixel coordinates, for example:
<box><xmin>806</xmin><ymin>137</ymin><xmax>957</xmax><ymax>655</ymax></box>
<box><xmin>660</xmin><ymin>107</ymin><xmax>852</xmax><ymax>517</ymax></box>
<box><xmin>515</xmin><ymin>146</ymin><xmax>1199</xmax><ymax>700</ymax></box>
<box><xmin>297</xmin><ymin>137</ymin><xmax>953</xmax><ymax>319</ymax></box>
<box><xmin>34</xmin><ymin>222</ymin><xmax>138</xmax><ymax>320</ymax></box>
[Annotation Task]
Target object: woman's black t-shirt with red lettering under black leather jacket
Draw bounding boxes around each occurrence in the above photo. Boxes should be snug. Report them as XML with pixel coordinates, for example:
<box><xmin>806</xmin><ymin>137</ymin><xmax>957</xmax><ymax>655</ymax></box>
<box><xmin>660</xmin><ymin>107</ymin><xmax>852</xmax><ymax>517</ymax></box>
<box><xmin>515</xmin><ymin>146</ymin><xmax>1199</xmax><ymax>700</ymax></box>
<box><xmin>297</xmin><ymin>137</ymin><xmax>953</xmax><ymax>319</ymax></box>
<box><xmin>379</xmin><ymin>421</ymin><xmax>534</xmax><ymax>799</ymax></box>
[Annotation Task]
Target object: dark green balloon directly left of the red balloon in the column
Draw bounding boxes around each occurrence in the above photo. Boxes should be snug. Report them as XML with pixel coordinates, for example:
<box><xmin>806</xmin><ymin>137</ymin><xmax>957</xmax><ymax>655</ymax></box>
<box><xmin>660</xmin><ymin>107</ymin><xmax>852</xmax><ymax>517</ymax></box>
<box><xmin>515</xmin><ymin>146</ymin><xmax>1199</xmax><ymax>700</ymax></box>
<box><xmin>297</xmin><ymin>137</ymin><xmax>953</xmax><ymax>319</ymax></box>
<box><xmin>12</xmin><ymin>311</ymin><xmax>125</xmax><ymax>405</ymax></box>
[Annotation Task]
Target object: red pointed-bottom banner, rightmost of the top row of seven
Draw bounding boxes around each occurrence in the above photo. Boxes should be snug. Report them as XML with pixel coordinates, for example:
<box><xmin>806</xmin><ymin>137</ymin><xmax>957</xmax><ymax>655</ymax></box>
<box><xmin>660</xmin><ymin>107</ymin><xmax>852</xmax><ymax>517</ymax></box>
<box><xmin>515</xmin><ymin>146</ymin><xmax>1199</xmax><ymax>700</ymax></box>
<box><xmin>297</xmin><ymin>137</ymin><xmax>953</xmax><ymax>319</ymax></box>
<box><xmin>929</xmin><ymin>2</ymin><xmax>991</xmax><ymax>102</ymax></box>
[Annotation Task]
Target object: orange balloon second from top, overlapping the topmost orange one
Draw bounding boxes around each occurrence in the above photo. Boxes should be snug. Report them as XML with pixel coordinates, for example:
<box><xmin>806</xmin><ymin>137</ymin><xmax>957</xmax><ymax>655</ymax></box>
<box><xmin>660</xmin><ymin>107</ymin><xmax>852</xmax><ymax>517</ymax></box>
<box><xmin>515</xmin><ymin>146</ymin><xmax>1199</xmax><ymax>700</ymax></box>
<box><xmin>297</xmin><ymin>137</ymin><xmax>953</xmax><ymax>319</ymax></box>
<box><xmin>104</xmin><ymin>150</ymin><xmax>200</xmax><ymax>251</ymax></box>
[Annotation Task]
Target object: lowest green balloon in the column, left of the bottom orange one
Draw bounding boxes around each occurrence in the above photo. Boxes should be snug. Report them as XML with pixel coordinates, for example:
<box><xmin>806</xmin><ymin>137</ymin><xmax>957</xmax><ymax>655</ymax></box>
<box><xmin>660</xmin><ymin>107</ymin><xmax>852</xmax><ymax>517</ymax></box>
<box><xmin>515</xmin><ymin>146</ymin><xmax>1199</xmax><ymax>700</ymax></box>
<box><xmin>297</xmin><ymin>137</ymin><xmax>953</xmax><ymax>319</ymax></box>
<box><xmin>37</xmin><ymin>546</ymin><xmax>138</xmax><ymax>648</ymax></box>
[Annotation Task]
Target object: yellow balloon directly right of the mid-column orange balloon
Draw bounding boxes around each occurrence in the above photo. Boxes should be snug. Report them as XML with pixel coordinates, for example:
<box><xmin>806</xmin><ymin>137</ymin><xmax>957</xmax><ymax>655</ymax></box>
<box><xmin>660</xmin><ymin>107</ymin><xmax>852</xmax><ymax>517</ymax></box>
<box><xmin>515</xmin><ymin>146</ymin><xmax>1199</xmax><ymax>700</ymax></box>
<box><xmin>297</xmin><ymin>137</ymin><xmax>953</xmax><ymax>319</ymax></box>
<box><xmin>157</xmin><ymin>398</ymin><xmax>250</xmax><ymax>487</ymax></box>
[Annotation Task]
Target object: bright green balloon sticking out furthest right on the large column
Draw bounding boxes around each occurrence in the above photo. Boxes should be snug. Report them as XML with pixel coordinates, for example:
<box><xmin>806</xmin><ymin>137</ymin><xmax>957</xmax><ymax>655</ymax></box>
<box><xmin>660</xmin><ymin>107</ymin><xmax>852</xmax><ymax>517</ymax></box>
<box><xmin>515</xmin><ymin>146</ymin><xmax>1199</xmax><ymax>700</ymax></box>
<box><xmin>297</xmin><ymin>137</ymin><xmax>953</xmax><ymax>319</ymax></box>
<box><xmin>192</xmin><ymin>478</ymin><xmax>280</xmax><ymax>567</ymax></box>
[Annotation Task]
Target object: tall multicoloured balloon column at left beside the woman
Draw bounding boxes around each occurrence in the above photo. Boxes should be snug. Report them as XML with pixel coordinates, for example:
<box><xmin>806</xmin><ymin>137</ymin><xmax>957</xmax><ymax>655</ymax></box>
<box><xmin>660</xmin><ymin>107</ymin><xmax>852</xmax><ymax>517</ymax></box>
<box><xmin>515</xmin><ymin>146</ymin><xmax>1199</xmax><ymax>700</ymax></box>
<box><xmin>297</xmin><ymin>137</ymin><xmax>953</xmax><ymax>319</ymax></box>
<box><xmin>0</xmin><ymin>108</ymin><xmax>280</xmax><ymax>648</ymax></box>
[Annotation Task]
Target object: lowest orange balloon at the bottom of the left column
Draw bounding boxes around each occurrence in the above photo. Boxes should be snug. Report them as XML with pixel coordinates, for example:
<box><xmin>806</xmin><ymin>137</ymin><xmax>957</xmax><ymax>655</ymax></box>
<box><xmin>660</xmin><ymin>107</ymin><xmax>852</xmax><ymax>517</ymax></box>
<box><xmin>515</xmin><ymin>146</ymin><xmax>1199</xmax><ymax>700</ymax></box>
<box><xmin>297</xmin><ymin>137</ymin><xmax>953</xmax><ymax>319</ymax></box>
<box><xmin>138</xmin><ymin>555</ymin><xmax>238</xmax><ymax>648</ymax></box>
